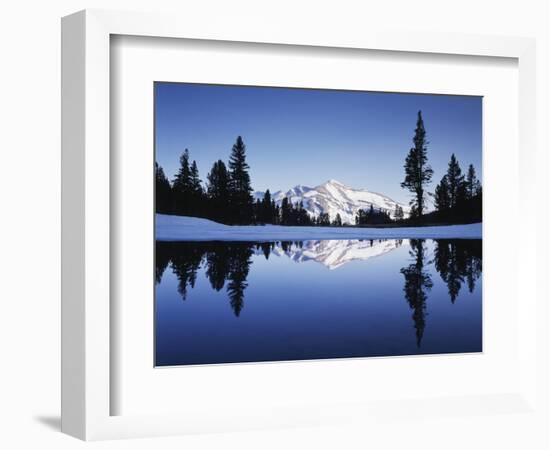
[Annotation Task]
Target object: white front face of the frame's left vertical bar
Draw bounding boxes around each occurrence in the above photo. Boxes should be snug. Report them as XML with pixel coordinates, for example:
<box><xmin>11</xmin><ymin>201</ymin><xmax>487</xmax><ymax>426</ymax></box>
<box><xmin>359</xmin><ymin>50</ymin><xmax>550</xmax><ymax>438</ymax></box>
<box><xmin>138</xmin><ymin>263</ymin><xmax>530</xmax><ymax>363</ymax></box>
<box><xmin>82</xmin><ymin>10</ymin><xmax>113</xmax><ymax>440</ymax></box>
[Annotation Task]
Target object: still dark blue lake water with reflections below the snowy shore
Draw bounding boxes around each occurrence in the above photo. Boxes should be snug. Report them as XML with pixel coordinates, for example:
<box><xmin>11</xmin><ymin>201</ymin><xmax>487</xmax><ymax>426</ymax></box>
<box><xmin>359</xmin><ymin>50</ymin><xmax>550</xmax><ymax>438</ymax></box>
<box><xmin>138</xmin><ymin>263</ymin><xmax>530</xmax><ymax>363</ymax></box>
<box><xmin>155</xmin><ymin>239</ymin><xmax>482</xmax><ymax>366</ymax></box>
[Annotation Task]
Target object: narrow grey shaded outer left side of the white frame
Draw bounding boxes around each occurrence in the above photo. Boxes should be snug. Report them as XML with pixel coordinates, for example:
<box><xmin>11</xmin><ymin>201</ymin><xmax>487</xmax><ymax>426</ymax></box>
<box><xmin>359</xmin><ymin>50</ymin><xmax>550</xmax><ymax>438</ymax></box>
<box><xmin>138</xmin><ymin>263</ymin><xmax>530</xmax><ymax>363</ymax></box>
<box><xmin>61</xmin><ymin>11</ymin><xmax>86</xmax><ymax>439</ymax></box>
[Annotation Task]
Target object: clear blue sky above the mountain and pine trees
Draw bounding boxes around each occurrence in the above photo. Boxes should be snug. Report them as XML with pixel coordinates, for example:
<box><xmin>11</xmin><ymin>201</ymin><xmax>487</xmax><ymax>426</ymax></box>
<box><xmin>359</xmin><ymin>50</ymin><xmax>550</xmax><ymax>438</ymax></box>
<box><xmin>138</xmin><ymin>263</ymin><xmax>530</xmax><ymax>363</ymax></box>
<box><xmin>155</xmin><ymin>83</ymin><xmax>482</xmax><ymax>202</ymax></box>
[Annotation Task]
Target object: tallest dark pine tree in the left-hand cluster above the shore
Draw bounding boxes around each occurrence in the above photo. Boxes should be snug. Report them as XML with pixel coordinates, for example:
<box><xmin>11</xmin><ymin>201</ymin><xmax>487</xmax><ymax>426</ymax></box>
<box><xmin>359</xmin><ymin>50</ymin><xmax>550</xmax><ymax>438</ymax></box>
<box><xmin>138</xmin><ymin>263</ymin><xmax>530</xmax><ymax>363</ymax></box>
<box><xmin>229</xmin><ymin>136</ymin><xmax>253</xmax><ymax>224</ymax></box>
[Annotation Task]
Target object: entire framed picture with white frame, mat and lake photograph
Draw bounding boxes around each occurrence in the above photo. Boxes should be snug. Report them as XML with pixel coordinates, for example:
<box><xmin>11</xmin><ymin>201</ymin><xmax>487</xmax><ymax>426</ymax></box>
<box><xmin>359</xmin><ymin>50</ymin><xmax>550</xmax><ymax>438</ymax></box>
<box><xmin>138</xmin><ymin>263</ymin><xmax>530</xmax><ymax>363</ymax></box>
<box><xmin>62</xmin><ymin>11</ymin><xmax>536</xmax><ymax>440</ymax></box>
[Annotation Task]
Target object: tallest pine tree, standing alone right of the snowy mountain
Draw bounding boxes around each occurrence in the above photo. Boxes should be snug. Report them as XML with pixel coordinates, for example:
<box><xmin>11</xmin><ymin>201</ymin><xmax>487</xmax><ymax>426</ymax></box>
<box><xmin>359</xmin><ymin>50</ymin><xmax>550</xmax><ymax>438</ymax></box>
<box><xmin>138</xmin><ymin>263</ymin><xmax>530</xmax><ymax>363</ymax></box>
<box><xmin>401</xmin><ymin>111</ymin><xmax>433</xmax><ymax>218</ymax></box>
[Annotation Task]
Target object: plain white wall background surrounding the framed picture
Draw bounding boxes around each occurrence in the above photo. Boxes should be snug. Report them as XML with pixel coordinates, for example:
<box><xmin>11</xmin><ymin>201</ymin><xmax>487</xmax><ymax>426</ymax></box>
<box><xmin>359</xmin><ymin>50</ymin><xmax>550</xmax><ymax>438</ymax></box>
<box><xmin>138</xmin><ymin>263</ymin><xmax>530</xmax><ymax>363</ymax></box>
<box><xmin>0</xmin><ymin>0</ymin><xmax>550</xmax><ymax>449</ymax></box>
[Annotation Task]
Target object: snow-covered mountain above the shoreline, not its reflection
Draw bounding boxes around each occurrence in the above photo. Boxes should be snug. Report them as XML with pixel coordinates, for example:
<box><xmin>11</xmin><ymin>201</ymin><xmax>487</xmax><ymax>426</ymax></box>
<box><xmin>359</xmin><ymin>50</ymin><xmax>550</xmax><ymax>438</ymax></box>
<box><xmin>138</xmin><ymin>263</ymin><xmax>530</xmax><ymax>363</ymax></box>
<box><xmin>254</xmin><ymin>180</ymin><xmax>410</xmax><ymax>224</ymax></box>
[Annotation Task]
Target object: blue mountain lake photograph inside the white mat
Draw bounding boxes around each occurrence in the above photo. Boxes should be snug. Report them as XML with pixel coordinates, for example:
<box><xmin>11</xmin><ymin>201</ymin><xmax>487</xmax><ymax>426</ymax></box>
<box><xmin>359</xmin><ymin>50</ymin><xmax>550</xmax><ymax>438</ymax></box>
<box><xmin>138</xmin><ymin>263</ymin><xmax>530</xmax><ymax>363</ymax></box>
<box><xmin>154</xmin><ymin>82</ymin><xmax>483</xmax><ymax>367</ymax></box>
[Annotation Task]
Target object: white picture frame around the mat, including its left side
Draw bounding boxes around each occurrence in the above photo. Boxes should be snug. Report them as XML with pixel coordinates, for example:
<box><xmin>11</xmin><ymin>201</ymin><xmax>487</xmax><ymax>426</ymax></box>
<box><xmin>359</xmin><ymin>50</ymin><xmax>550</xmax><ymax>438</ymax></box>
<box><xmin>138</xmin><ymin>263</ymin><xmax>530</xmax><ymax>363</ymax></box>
<box><xmin>62</xmin><ymin>10</ymin><xmax>537</xmax><ymax>440</ymax></box>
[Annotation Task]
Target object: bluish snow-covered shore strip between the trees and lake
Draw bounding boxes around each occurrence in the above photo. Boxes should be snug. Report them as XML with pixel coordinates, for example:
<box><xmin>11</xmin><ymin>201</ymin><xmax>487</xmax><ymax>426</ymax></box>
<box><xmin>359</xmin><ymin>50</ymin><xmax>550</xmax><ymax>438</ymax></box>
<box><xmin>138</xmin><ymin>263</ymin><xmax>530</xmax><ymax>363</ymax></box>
<box><xmin>155</xmin><ymin>214</ymin><xmax>482</xmax><ymax>242</ymax></box>
